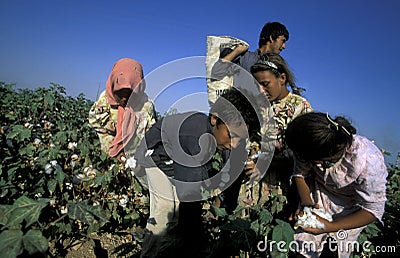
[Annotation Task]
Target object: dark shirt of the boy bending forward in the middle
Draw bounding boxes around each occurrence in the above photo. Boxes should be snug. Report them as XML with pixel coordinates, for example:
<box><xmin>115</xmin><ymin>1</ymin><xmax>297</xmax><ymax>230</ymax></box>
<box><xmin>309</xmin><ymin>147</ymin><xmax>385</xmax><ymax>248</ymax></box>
<box><xmin>135</xmin><ymin>112</ymin><xmax>216</xmax><ymax>182</ymax></box>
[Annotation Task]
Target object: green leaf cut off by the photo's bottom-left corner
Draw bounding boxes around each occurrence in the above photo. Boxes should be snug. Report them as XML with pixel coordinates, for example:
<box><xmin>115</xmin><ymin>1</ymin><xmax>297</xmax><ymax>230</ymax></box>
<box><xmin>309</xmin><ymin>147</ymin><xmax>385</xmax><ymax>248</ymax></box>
<box><xmin>0</xmin><ymin>229</ymin><xmax>23</xmax><ymax>258</ymax></box>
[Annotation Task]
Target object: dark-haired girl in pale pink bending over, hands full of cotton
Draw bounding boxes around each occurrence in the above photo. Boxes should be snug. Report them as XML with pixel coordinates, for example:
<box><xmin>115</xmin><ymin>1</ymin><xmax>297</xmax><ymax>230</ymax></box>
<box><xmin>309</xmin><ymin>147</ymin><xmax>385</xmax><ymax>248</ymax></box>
<box><xmin>285</xmin><ymin>112</ymin><xmax>387</xmax><ymax>257</ymax></box>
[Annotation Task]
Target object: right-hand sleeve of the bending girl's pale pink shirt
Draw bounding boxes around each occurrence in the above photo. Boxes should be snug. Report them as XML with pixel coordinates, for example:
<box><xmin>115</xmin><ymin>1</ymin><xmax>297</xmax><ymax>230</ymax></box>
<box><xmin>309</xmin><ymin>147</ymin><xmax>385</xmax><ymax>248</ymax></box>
<box><xmin>356</xmin><ymin>140</ymin><xmax>388</xmax><ymax>222</ymax></box>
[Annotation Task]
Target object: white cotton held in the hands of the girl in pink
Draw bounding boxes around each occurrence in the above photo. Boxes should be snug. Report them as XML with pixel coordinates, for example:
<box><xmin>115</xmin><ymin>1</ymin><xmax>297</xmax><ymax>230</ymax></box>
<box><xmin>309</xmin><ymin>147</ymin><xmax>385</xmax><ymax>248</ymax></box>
<box><xmin>294</xmin><ymin>207</ymin><xmax>332</xmax><ymax>229</ymax></box>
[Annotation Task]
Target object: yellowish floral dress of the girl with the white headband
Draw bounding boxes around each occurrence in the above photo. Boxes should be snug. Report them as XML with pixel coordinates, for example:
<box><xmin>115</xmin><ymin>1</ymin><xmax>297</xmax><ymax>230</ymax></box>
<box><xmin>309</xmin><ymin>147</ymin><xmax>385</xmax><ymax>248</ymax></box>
<box><xmin>239</xmin><ymin>92</ymin><xmax>313</xmax><ymax>209</ymax></box>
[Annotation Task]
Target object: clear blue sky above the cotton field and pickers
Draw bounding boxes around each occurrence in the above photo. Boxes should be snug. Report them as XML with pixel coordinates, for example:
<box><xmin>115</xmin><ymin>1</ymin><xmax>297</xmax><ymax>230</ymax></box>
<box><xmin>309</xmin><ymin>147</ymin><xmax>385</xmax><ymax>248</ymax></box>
<box><xmin>0</xmin><ymin>0</ymin><xmax>400</xmax><ymax>163</ymax></box>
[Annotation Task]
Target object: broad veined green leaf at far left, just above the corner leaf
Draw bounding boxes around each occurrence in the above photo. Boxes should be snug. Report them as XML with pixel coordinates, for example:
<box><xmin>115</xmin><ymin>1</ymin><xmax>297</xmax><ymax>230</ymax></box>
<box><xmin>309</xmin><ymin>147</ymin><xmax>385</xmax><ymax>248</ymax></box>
<box><xmin>7</xmin><ymin>196</ymin><xmax>46</xmax><ymax>227</ymax></box>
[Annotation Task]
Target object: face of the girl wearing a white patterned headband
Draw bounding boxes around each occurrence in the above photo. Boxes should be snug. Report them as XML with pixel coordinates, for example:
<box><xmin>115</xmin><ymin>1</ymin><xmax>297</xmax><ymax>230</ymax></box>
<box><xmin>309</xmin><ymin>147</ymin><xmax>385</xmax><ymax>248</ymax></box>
<box><xmin>254</xmin><ymin>71</ymin><xmax>289</xmax><ymax>102</ymax></box>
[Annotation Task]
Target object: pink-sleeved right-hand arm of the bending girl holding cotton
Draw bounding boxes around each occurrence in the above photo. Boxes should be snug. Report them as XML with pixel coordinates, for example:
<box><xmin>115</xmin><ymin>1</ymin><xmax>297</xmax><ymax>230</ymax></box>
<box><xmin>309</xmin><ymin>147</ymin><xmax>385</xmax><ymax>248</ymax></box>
<box><xmin>305</xmin><ymin>135</ymin><xmax>387</xmax><ymax>234</ymax></box>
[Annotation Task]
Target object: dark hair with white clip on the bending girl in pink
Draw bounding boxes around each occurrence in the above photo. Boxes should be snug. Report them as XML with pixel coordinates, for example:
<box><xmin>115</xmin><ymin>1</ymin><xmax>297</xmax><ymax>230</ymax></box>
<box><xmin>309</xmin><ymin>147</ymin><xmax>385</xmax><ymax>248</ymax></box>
<box><xmin>285</xmin><ymin>112</ymin><xmax>356</xmax><ymax>160</ymax></box>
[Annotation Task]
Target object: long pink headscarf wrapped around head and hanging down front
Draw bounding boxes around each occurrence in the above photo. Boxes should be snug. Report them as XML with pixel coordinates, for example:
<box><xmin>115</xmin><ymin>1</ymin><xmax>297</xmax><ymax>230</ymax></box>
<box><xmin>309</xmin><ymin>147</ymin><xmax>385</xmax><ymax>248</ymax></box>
<box><xmin>106</xmin><ymin>58</ymin><xmax>146</xmax><ymax>157</ymax></box>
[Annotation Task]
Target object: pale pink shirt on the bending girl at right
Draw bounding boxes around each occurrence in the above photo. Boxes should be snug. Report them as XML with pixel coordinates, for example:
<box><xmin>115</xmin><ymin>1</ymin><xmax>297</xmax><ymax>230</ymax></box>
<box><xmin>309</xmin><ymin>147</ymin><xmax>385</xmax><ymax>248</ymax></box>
<box><xmin>294</xmin><ymin>135</ymin><xmax>388</xmax><ymax>221</ymax></box>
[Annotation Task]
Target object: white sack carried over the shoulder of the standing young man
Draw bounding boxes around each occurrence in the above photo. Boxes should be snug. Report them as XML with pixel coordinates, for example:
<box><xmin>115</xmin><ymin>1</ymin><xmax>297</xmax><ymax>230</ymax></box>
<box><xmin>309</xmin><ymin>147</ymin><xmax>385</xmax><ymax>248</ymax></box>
<box><xmin>206</xmin><ymin>36</ymin><xmax>249</xmax><ymax>105</ymax></box>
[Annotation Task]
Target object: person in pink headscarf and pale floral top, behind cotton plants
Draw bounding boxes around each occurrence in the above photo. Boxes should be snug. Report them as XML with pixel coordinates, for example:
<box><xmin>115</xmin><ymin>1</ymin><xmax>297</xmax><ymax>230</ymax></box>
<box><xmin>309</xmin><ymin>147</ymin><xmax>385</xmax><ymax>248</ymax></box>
<box><xmin>89</xmin><ymin>58</ymin><xmax>156</xmax><ymax>160</ymax></box>
